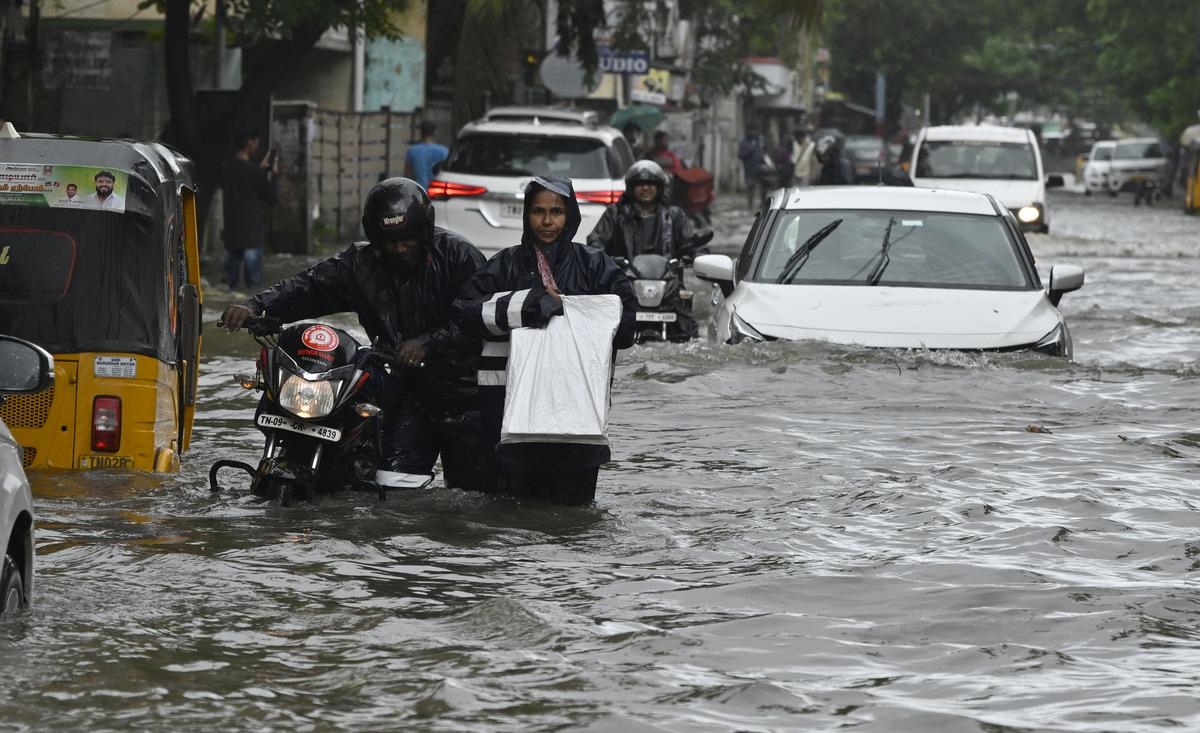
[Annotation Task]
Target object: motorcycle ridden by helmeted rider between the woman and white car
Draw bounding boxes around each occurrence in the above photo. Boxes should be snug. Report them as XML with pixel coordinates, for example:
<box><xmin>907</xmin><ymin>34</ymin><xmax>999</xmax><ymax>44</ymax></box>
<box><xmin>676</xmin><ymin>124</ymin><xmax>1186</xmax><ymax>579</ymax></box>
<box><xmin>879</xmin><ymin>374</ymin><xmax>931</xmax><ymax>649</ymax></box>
<box><xmin>616</xmin><ymin>229</ymin><xmax>713</xmax><ymax>343</ymax></box>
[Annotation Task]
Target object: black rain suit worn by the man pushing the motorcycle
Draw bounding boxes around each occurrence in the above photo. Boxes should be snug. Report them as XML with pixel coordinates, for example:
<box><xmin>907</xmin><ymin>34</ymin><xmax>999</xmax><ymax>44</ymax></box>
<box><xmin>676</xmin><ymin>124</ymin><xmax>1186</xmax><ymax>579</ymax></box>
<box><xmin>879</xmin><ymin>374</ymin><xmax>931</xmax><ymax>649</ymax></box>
<box><xmin>244</xmin><ymin>228</ymin><xmax>485</xmax><ymax>488</ymax></box>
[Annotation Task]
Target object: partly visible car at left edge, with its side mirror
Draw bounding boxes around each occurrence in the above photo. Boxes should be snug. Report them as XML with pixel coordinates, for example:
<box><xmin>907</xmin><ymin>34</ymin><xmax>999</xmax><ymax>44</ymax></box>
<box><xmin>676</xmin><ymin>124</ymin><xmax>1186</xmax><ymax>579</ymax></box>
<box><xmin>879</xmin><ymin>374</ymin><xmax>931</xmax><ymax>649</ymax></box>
<box><xmin>0</xmin><ymin>336</ymin><xmax>54</xmax><ymax>614</ymax></box>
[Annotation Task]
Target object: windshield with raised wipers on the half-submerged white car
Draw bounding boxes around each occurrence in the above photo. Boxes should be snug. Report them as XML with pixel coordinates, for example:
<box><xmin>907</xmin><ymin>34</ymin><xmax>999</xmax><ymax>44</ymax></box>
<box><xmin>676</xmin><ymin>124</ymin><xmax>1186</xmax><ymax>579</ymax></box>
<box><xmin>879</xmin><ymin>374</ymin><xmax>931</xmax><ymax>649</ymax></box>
<box><xmin>752</xmin><ymin>210</ymin><xmax>1032</xmax><ymax>290</ymax></box>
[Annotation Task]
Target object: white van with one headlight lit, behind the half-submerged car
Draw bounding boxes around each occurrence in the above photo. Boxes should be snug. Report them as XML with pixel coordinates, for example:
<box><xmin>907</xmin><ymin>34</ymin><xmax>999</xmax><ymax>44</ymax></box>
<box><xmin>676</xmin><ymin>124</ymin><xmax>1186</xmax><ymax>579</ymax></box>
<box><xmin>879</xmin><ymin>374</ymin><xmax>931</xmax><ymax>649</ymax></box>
<box><xmin>910</xmin><ymin>125</ymin><xmax>1062</xmax><ymax>233</ymax></box>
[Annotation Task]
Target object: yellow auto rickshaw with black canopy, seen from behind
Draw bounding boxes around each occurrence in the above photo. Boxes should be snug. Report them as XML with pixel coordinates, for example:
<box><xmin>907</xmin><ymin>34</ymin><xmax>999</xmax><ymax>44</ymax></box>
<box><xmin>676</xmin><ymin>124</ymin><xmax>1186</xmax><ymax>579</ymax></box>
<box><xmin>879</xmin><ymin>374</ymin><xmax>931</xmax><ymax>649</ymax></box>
<box><xmin>0</xmin><ymin>132</ymin><xmax>203</xmax><ymax>471</ymax></box>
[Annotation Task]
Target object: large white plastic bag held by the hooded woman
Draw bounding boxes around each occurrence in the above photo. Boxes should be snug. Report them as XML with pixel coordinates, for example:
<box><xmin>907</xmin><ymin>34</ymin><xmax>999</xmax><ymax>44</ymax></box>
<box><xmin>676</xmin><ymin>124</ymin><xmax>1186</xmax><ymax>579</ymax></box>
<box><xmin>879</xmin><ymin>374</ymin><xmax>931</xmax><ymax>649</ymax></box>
<box><xmin>500</xmin><ymin>295</ymin><xmax>620</xmax><ymax>445</ymax></box>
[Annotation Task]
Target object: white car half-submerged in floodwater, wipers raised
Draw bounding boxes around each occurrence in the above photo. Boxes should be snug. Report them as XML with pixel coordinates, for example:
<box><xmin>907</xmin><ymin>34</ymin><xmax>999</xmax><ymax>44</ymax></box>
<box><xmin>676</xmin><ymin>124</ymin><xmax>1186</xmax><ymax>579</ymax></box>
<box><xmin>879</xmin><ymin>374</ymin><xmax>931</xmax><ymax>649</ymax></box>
<box><xmin>694</xmin><ymin>186</ymin><xmax>1084</xmax><ymax>358</ymax></box>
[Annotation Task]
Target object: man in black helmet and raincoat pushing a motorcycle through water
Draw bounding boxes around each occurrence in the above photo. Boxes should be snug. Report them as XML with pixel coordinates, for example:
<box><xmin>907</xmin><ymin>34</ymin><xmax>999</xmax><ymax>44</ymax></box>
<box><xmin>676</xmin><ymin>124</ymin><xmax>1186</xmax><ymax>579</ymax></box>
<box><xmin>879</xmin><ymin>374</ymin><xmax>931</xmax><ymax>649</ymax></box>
<box><xmin>222</xmin><ymin>178</ymin><xmax>487</xmax><ymax>489</ymax></box>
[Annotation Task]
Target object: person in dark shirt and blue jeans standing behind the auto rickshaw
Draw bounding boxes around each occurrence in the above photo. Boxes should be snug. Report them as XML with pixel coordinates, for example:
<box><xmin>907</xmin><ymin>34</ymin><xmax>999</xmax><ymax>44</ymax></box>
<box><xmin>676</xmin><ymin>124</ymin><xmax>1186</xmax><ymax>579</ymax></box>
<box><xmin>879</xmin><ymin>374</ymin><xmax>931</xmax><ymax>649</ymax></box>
<box><xmin>221</xmin><ymin>130</ymin><xmax>280</xmax><ymax>290</ymax></box>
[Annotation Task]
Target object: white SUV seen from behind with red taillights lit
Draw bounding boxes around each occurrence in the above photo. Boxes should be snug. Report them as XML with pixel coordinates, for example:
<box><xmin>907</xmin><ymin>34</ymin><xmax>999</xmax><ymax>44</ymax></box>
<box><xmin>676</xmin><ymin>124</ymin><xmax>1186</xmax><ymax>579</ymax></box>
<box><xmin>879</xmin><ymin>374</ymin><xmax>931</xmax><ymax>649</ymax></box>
<box><xmin>430</xmin><ymin>107</ymin><xmax>634</xmax><ymax>257</ymax></box>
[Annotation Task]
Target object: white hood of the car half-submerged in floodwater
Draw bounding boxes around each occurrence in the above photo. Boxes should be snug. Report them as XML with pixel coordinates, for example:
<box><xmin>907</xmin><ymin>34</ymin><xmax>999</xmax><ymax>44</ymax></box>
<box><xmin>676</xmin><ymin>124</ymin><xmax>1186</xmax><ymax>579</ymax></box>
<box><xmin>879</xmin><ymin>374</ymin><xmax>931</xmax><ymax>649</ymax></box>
<box><xmin>732</xmin><ymin>283</ymin><xmax>1062</xmax><ymax>349</ymax></box>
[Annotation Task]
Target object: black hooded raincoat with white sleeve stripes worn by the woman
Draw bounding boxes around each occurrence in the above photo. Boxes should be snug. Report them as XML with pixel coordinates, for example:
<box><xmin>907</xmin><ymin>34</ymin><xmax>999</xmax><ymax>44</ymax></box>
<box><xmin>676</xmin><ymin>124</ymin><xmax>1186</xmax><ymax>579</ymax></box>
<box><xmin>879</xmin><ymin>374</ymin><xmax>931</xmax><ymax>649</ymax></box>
<box><xmin>454</xmin><ymin>178</ymin><xmax>637</xmax><ymax>501</ymax></box>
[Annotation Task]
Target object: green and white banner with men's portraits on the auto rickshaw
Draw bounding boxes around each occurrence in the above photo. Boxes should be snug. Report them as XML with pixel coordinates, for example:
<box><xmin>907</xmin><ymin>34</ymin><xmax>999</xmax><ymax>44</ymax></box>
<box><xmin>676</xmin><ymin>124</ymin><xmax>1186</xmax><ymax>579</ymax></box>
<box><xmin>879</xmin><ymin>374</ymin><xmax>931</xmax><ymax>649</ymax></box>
<box><xmin>0</xmin><ymin>163</ymin><xmax>130</xmax><ymax>214</ymax></box>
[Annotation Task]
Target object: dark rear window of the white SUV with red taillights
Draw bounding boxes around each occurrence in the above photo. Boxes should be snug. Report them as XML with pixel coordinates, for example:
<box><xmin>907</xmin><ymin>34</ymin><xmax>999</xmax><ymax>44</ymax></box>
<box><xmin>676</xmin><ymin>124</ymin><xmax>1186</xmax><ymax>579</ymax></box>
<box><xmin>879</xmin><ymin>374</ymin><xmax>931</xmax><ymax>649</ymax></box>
<box><xmin>444</xmin><ymin>134</ymin><xmax>614</xmax><ymax>179</ymax></box>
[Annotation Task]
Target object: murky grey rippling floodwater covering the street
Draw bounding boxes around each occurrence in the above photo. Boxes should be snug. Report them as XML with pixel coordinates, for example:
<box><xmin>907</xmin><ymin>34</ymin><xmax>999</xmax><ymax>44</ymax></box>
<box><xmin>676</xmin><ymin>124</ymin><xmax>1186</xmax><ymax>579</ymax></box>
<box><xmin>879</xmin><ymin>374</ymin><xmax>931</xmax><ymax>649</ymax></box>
<box><xmin>0</xmin><ymin>194</ymin><xmax>1200</xmax><ymax>733</ymax></box>
